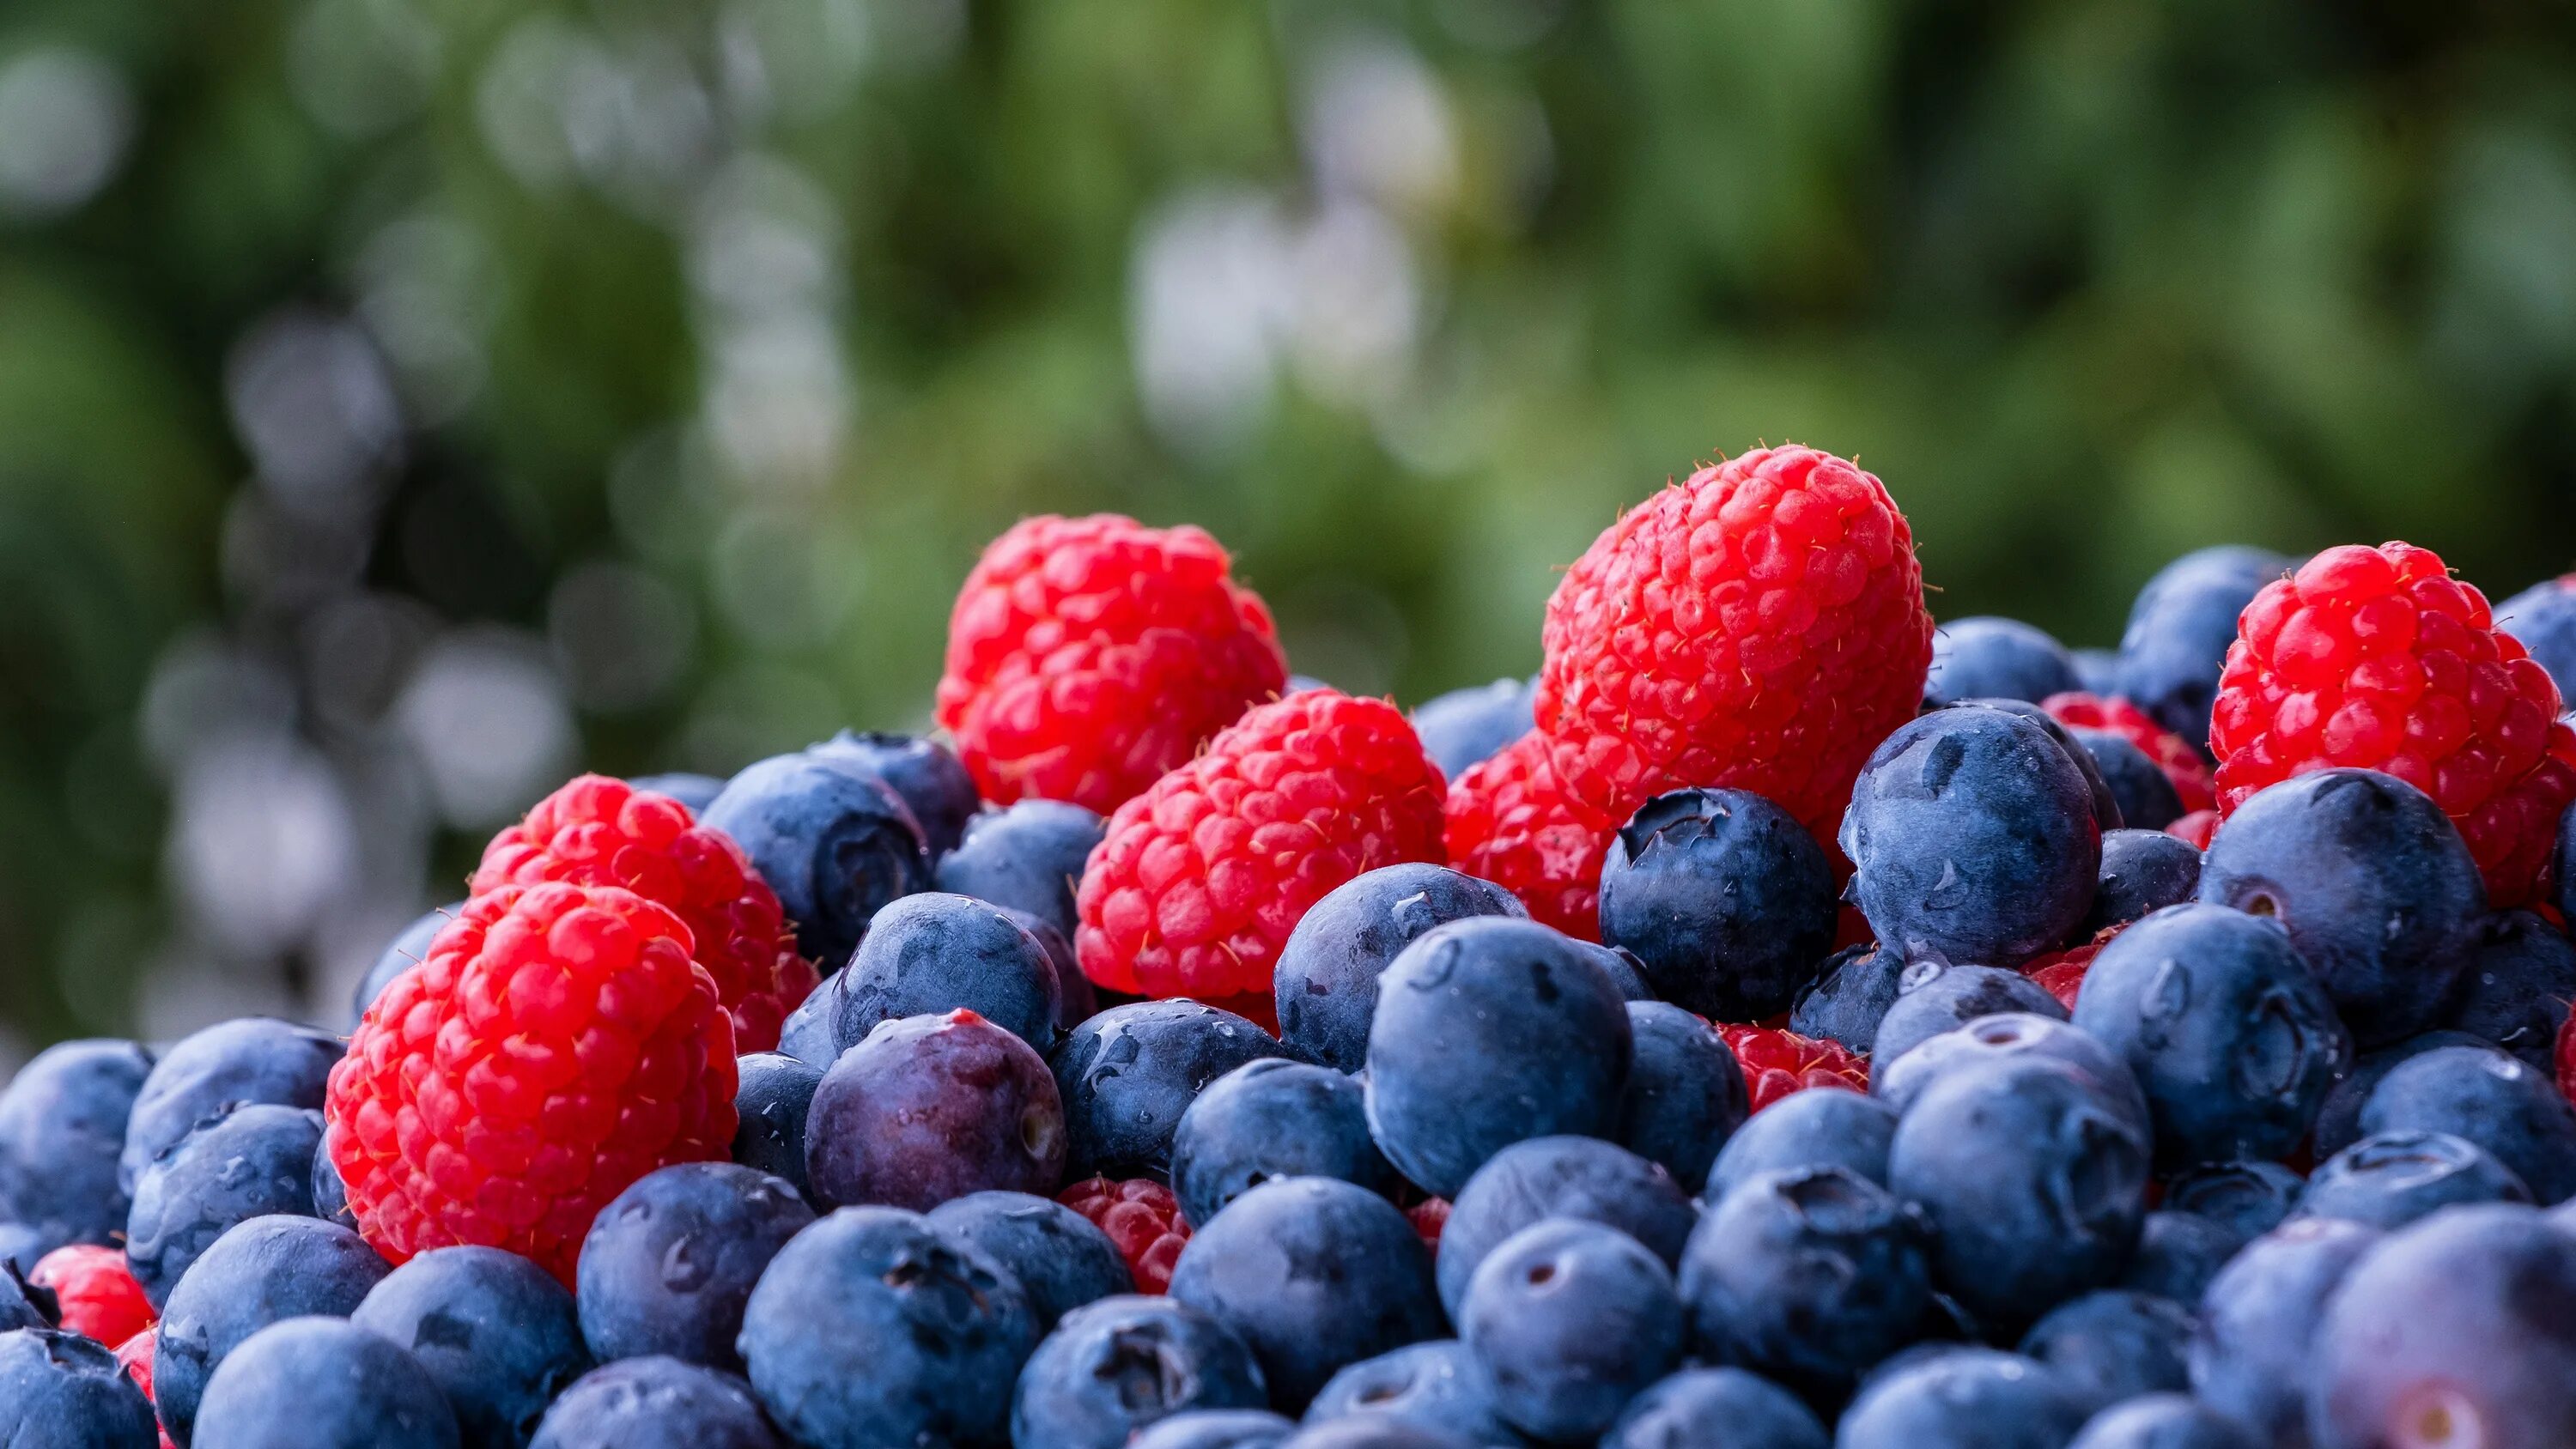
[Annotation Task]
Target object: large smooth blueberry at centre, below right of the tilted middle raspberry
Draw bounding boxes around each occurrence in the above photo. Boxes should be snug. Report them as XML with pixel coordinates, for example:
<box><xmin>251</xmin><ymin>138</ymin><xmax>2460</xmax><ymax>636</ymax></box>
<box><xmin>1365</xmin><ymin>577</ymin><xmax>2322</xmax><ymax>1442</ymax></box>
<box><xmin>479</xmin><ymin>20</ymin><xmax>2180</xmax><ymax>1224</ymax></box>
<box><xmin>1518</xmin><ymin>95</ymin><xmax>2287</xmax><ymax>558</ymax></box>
<box><xmin>1368</xmin><ymin>916</ymin><xmax>1633</xmax><ymax>1197</ymax></box>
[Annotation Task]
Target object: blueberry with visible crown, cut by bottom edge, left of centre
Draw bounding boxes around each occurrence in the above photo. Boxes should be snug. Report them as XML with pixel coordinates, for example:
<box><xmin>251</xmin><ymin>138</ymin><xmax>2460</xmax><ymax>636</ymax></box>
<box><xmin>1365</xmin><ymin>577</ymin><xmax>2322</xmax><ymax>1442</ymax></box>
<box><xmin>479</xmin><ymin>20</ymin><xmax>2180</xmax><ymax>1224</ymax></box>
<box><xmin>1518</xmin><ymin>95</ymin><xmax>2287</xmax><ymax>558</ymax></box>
<box><xmin>1010</xmin><ymin>1294</ymin><xmax>1265</xmax><ymax>1449</ymax></box>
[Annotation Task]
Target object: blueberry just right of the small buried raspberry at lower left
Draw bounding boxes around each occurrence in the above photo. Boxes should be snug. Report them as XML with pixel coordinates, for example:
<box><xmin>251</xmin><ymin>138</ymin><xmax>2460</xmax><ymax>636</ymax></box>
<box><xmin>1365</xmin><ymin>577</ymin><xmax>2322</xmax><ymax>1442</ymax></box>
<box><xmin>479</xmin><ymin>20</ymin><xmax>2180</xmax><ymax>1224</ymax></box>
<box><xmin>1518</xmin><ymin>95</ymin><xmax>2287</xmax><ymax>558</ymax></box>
<box><xmin>152</xmin><ymin>1217</ymin><xmax>394</xmax><ymax>1444</ymax></box>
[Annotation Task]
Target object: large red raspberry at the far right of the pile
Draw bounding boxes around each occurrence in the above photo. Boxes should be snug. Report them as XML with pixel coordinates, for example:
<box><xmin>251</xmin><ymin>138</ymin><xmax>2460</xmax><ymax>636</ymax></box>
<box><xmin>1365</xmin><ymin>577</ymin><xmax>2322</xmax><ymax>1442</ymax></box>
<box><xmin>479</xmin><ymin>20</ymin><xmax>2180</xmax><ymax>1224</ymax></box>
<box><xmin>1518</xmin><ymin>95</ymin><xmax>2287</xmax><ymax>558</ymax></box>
<box><xmin>2210</xmin><ymin>543</ymin><xmax>2576</xmax><ymax>908</ymax></box>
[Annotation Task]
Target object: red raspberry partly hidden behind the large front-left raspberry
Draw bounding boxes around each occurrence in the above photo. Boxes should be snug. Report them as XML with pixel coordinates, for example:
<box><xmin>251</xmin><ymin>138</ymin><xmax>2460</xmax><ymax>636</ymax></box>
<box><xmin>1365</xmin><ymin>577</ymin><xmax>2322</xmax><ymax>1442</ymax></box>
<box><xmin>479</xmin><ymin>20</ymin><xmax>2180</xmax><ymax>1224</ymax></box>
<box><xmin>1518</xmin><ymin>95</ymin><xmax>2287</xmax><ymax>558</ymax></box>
<box><xmin>474</xmin><ymin>774</ymin><xmax>819</xmax><ymax>1052</ymax></box>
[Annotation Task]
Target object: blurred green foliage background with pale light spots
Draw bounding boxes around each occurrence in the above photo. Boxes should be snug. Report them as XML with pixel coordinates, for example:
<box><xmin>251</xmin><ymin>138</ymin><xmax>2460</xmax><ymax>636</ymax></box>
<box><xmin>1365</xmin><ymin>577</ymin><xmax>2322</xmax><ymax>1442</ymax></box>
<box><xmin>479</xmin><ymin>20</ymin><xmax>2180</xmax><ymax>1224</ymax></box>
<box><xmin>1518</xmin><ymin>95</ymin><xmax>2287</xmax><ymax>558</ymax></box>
<box><xmin>0</xmin><ymin>0</ymin><xmax>2576</xmax><ymax>1055</ymax></box>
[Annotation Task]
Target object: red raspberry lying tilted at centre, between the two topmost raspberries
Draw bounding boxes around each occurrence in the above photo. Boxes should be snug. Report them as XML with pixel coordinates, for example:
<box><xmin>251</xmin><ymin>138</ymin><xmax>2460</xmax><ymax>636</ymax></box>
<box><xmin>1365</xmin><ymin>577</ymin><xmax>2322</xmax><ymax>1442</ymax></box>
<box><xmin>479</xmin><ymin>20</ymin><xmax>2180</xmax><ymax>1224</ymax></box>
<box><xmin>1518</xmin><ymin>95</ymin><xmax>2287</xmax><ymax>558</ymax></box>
<box><xmin>1074</xmin><ymin>690</ymin><xmax>1443</xmax><ymax>998</ymax></box>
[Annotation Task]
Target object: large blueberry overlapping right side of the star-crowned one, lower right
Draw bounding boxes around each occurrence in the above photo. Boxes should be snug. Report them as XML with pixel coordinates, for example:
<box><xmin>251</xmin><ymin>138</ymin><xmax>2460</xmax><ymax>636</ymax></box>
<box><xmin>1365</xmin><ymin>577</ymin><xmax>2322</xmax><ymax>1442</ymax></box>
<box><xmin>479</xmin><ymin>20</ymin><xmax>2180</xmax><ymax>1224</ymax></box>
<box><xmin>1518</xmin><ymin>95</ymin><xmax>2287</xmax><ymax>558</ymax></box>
<box><xmin>1888</xmin><ymin>1058</ymin><xmax>2148</xmax><ymax>1325</ymax></box>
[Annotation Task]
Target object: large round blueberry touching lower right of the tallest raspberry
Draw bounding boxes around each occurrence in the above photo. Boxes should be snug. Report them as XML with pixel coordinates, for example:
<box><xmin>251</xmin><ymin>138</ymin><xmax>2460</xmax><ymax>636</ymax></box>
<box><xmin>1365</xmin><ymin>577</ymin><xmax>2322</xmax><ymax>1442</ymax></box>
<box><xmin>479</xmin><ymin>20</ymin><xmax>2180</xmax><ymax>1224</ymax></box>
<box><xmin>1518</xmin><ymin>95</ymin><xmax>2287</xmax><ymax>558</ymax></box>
<box><xmin>1842</xmin><ymin>708</ymin><xmax>2102</xmax><ymax>967</ymax></box>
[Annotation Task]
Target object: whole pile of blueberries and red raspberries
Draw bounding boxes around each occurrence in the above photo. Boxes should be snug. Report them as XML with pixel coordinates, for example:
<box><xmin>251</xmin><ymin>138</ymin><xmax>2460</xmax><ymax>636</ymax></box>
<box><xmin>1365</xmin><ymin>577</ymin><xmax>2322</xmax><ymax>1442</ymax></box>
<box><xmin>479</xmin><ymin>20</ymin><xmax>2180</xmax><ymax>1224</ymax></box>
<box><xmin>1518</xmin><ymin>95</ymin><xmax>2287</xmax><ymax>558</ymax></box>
<box><xmin>0</xmin><ymin>448</ymin><xmax>2576</xmax><ymax>1449</ymax></box>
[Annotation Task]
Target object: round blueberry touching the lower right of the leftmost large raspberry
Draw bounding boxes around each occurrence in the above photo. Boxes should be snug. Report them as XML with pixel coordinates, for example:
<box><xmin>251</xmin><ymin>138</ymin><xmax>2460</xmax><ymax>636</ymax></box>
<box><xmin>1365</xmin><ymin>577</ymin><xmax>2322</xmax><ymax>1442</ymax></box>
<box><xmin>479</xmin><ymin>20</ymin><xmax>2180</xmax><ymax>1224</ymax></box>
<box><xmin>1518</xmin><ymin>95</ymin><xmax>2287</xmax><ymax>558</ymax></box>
<box><xmin>574</xmin><ymin>1163</ymin><xmax>814</xmax><ymax>1369</ymax></box>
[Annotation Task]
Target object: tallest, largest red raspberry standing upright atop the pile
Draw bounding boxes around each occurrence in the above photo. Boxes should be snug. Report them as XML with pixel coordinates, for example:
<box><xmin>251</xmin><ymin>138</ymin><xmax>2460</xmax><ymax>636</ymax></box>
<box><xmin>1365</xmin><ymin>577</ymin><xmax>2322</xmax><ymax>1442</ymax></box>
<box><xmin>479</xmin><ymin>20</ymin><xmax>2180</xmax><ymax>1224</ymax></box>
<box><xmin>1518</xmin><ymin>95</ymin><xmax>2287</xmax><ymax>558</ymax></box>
<box><xmin>1538</xmin><ymin>448</ymin><xmax>1932</xmax><ymax>841</ymax></box>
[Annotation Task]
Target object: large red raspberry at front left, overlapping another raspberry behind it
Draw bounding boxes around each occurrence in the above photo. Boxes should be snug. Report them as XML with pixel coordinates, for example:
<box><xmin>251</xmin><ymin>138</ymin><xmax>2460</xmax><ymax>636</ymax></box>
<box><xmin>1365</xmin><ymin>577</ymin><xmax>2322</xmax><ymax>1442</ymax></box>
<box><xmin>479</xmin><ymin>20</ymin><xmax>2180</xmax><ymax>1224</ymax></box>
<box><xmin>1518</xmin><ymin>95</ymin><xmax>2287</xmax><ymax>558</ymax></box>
<box><xmin>325</xmin><ymin>882</ymin><xmax>734</xmax><ymax>1284</ymax></box>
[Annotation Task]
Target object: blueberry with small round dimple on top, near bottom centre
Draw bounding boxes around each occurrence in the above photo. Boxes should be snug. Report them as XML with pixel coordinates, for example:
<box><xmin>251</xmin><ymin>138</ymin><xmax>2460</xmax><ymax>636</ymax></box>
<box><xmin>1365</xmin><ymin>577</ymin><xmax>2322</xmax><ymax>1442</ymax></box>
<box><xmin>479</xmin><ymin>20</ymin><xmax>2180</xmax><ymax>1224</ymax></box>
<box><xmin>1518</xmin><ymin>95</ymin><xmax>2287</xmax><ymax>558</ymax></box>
<box><xmin>1458</xmin><ymin>1217</ymin><xmax>1685</xmax><ymax>1441</ymax></box>
